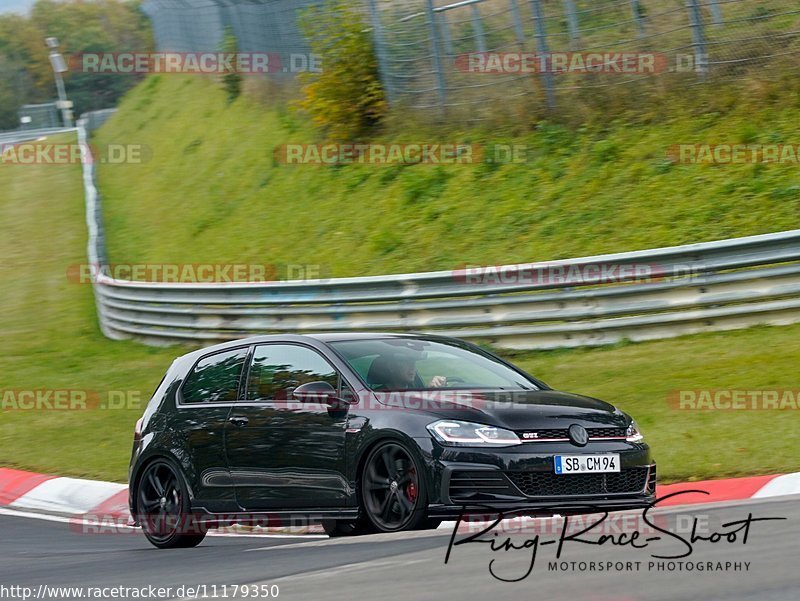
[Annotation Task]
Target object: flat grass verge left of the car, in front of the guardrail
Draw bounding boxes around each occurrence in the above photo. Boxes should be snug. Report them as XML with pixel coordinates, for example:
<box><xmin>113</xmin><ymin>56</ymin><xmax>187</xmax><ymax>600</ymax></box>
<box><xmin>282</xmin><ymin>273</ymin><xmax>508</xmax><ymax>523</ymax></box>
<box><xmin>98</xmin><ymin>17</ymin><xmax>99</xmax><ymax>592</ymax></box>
<box><xmin>0</xmin><ymin>134</ymin><xmax>180</xmax><ymax>481</ymax></box>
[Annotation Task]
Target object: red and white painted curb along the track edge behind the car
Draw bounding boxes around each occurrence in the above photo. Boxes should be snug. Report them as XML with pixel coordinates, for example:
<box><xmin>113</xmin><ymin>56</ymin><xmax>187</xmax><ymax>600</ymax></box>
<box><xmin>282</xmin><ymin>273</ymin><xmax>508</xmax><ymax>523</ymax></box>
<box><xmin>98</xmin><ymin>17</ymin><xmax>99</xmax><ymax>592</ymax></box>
<box><xmin>0</xmin><ymin>468</ymin><xmax>800</xmax><ymax>534</ymax></box>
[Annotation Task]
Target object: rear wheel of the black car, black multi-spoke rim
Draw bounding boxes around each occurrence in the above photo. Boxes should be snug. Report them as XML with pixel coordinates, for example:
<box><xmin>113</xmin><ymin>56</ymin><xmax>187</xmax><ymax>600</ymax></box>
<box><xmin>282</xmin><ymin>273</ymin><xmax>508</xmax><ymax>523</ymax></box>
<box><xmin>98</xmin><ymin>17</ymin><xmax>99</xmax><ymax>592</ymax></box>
<box><xmin>136</xmin><ymin>459</ymin><xmax>208</xmax><ymax>549</ymax></box>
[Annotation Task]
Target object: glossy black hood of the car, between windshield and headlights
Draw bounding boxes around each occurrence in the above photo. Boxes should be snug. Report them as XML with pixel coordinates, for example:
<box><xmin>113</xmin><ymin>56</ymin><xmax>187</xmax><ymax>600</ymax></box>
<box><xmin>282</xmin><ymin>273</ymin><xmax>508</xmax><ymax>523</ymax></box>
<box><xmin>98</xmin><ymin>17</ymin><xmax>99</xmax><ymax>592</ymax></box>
<box><xmin>368</xmin><ymin>389</ymin><xmax>628</xmax><ymax>430</ymax></box>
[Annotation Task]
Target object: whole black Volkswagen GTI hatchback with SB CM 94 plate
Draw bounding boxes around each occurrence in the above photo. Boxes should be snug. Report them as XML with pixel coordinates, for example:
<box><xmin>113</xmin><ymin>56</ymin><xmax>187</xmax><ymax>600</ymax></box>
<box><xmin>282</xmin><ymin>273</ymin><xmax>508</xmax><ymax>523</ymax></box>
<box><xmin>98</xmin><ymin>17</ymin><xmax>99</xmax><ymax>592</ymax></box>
<box><xmin>130</xmin><ymin>333</ymin><xmax>656</xmax><ymax>548</ymax></box>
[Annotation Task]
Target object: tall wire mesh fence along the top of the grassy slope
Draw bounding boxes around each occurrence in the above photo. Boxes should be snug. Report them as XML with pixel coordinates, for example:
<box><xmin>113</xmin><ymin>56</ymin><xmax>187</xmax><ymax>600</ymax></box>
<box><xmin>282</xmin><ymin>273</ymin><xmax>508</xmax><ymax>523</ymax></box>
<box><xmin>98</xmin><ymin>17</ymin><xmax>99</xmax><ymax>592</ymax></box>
<box><xmin>138</xmin><ymin>0</ymin><xmax>800</xmax><ymax>114</ymax></box>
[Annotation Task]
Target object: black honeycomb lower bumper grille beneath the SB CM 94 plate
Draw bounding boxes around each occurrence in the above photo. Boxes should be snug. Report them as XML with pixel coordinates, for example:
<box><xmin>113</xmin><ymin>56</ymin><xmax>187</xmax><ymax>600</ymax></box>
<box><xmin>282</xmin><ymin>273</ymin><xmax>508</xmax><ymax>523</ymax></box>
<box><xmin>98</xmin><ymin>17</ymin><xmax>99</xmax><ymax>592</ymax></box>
<box><xmin>506</xmin><ymin>467</ymin><xmax>648</xmax><ymax>497</ymax></box>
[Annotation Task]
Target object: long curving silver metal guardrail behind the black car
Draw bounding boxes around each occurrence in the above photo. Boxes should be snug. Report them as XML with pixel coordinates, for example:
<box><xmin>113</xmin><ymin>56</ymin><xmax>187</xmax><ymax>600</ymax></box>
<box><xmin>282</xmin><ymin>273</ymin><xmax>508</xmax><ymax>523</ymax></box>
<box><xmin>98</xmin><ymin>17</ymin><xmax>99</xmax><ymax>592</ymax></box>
<box><xmin>78</xmin><ymin>114</ymin><xmax>800</xmax><ymax>349</ymax></box>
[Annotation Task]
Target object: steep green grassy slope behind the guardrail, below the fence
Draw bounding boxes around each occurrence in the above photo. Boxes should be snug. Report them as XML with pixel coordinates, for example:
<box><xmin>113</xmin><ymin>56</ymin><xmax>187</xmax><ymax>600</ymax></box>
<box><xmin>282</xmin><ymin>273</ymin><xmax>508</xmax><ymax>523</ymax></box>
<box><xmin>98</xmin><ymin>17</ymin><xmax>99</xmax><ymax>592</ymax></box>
<box><xmin>90</xmin><ymin>75</ymin><xmax>800</xmax><ymax>276</ymax></box>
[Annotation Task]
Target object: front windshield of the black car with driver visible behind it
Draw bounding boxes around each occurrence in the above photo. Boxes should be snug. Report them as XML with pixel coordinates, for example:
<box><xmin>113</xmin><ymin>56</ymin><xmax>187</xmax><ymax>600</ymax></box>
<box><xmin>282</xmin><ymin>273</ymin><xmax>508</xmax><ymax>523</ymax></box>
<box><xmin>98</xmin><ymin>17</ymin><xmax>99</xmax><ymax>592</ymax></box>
<box><xmin>331</xmin><ymin>338</ymin><xmax>539</xmax><ymax>391</ymax></box>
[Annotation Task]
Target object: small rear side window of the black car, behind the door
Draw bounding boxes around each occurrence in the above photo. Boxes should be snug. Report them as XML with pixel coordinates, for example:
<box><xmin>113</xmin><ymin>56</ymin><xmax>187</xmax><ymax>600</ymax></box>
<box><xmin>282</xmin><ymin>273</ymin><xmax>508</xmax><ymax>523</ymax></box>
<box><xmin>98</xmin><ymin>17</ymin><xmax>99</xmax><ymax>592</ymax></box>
<box><xmin>182</xmin><ymin>349</ymin><xmax>247</xmax><ymax>403</ymax></box>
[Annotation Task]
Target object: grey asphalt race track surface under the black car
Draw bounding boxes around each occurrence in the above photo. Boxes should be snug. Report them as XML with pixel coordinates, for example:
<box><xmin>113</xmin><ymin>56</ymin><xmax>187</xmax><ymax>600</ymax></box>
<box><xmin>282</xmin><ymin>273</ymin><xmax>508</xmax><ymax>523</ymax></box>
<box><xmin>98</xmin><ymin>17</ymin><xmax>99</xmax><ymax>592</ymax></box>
<box><xmin>0</xmin><ymin>497</ymin><xmax>800</xmax><ymax>601</ymax></box>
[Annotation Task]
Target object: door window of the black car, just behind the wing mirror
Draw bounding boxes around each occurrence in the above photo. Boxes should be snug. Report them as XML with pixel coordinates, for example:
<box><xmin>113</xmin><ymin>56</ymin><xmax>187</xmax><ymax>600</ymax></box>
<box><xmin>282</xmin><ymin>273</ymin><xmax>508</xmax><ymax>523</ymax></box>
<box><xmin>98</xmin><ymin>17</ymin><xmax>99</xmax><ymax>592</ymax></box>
<box><xmin>247</xmin><ymin>344</ymin><xmax>338</xmax><ymax>401</ymax></box>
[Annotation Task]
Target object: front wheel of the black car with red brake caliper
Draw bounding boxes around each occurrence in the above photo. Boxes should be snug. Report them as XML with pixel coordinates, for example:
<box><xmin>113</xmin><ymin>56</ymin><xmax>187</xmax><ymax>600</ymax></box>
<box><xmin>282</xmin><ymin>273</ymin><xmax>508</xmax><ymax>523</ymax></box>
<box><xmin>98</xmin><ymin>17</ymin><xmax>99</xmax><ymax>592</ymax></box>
<box><xmin>361</xmin><ymin>441</ymin><xmax>428</xmax><ymax>532</ymax></box>
